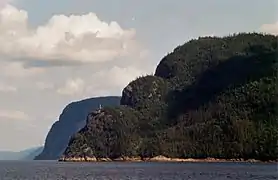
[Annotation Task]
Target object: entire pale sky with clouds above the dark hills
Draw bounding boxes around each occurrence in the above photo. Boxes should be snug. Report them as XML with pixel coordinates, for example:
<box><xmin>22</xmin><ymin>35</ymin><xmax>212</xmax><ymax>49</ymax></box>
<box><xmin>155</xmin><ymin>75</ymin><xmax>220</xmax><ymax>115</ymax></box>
<box><xmin>0</xmin><ymin>0</ymin><xmax>278</xmax><ymax>151</ymax></box>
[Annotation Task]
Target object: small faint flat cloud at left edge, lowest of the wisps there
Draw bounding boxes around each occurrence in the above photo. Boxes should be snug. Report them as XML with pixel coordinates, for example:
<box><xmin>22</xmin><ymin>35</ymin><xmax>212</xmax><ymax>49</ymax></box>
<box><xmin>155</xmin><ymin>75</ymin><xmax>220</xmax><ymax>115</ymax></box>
<box><xmin>0</xmin><ymin>110</ymin><xmax>30</xmax><ymax>121</ymax></box>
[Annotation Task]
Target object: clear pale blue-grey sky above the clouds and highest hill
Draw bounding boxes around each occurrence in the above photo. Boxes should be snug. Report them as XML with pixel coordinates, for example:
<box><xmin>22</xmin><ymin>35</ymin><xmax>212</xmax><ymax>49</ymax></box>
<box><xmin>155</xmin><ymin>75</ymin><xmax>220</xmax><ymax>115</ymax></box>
<box><xmin>17</xmin><ymin>0</ymin><xmax>278</xmax><ymax>61</ymax></box>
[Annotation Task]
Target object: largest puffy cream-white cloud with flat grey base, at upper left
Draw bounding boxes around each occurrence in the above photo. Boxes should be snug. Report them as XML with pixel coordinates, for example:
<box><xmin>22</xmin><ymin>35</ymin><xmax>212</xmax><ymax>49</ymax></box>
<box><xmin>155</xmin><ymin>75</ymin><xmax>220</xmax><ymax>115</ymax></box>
<box><xmin>0</xmin><ymin>5</ymin><xmax>143</xmax><ymax>67</ymax></box>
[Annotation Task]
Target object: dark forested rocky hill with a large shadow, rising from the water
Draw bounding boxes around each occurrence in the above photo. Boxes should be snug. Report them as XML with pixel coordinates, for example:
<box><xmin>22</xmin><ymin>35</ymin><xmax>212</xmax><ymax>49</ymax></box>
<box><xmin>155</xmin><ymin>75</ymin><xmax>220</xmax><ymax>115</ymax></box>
<box><xmin>63</xmin><ymin>33</ymin><xmax>278</xmax><ymax>161</ymax></box>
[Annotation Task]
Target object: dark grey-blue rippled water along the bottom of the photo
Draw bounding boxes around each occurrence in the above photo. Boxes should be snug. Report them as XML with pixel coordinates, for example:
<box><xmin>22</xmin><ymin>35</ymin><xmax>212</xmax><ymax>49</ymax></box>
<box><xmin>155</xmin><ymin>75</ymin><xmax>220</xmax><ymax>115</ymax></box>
<box><xmin>0</xmin><ymin>161</ymin><xmax>278</xmax><ymax>180</ymax></box>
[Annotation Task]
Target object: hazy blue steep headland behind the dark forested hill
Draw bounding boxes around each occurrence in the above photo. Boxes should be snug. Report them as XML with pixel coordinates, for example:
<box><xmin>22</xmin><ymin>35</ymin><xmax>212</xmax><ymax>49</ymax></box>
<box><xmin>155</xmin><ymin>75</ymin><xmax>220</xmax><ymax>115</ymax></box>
<box><xmin>35</xmin><ymin>96</ymin><xmax>120</xmax><ymax>160</ymax></box>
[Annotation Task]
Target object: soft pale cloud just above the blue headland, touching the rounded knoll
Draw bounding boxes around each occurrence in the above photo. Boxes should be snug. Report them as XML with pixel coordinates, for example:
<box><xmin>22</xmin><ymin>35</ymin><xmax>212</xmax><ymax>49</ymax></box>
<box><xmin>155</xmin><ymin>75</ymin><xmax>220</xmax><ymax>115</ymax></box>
<box><xmin>54</xmin><ymin>66</ymin><xmax>146</xmax><ymax>98</ymax></box>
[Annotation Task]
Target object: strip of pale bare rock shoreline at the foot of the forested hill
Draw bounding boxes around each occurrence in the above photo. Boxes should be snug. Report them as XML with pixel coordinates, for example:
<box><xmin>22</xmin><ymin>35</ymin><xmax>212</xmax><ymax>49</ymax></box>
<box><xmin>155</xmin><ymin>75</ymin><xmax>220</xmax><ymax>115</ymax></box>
<box><xmin>58</xmin><ymin>156</ymin><xmax>278</xmax><ymax>163</ymax></box>
